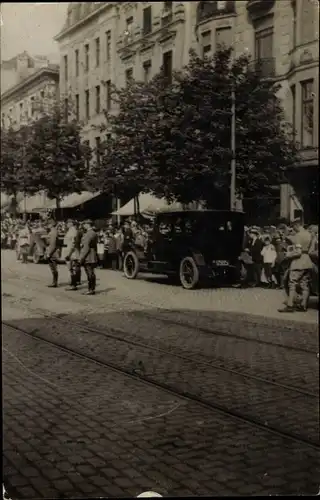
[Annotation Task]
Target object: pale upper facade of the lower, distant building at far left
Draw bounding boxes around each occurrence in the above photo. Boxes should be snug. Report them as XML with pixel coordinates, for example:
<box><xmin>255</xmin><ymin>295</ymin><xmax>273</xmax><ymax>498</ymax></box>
<box><xmin>1</xmin><ymin>65</ymin><xmax>59</xmax><ymax>129</ymax></box>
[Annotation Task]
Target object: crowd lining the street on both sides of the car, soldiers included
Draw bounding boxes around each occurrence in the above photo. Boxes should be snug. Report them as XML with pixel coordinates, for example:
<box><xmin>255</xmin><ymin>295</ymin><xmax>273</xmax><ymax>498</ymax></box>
<box><xmin>1</xmin><ymin>216</ymin><xmax>318</xmax><ymax>312</ymax></box>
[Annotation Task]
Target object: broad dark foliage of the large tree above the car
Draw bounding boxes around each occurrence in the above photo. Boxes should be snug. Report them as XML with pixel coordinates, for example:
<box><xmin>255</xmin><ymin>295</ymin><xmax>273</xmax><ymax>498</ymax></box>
<box><xmin>93</xmin><ymin>49</ymin><xmax>297</xmax><ymax>207</ymax></box>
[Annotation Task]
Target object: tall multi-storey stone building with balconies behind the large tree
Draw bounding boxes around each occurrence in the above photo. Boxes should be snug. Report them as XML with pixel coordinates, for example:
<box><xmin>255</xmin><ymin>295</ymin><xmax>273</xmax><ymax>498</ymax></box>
<box><xmin>56</xmin><ymin>0</ymin><xmax>319</xmax><ymax>220</ymax></box>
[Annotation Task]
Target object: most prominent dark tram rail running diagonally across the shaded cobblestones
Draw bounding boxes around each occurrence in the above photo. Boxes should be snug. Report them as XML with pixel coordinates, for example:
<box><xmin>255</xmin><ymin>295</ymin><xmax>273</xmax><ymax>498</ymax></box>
<box><xmin>2</xmin><ymin>318</ymin><xmax>320</xmax><ymax>451</ymax></box>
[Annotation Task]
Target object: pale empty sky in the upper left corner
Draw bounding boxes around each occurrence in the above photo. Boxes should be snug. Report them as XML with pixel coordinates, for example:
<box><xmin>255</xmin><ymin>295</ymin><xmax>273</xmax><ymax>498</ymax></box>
<box><xmin>0</xmin><ymin>2</ymin><xmax>68</xmax><ymax>60</ymax></box>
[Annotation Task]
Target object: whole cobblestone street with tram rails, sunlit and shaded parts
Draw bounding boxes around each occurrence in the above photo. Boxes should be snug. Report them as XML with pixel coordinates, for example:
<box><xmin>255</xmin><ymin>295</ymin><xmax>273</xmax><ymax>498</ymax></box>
<box><xmin>2</xmin><ymin>251</ymin><xmax>320</xmax><ymax>499</ymax></box>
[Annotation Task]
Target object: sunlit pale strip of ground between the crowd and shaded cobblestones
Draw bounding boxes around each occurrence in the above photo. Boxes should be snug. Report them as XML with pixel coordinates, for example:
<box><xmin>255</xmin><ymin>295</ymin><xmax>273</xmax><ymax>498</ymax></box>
<box><xmin>1</xmin><ymin>251</ymin><xmax>318</xmax><ymax>324</ymax></box>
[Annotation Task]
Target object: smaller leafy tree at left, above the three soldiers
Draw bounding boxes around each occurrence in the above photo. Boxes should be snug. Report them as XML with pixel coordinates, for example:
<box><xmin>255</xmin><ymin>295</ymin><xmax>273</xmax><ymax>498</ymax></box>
<box><xmin>23</xmin><ymin>97</ymin><xmax>90</xmax><ymax>208</ymax></box>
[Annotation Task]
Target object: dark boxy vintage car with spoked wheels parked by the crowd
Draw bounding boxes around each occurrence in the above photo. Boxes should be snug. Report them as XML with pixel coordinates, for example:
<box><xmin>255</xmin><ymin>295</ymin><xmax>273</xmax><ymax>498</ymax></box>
<box><xmin>123</xmin><ymin>210</ymin><xmax>244</xmax><ymax>290</ymax></box>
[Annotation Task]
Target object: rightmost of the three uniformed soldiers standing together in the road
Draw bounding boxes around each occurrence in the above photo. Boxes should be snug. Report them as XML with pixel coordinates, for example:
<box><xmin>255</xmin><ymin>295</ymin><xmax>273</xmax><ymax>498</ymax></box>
<box><xmin>80</xmin><ymin>220</ymin><xmax>98</xmax><ymax>295</ymax></box>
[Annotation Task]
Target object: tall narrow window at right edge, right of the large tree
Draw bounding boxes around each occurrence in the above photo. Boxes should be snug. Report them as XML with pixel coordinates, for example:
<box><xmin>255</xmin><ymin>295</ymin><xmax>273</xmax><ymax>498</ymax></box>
<box><xmin>301</xmin><ymin>80</ymin><xmax>314</xmax><ymax>148</ymax></box>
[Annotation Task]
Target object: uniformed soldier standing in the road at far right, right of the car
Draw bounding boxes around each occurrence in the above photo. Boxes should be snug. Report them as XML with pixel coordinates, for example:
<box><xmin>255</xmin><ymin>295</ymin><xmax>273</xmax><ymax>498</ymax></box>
<box><xmin>279</xmin><ymin>219</ymin><xmax>312</xmax><ymax>313</ymax></box>
